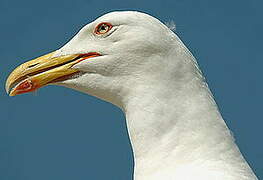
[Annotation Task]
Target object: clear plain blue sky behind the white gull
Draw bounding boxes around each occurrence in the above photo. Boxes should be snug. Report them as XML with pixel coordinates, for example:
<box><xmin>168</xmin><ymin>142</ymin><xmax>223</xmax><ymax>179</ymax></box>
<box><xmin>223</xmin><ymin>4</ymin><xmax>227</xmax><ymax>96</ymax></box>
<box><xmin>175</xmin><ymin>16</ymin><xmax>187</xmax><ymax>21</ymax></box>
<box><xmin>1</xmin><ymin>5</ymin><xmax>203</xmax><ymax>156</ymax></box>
<box><xmin>0</xmin><ymin>0</ymin><xmax>263</xmax><ymax>180</ymax></box>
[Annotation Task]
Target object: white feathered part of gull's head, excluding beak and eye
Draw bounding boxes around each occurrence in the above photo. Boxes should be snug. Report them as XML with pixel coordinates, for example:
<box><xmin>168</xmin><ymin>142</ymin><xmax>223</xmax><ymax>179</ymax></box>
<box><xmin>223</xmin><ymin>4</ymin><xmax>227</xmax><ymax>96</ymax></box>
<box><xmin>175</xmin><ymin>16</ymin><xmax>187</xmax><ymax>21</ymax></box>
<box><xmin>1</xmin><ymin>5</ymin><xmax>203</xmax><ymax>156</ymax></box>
<box><xmin>55</xmin><ymin>11</ymin><xmax>182</xmax><ymax>105</ymax></box>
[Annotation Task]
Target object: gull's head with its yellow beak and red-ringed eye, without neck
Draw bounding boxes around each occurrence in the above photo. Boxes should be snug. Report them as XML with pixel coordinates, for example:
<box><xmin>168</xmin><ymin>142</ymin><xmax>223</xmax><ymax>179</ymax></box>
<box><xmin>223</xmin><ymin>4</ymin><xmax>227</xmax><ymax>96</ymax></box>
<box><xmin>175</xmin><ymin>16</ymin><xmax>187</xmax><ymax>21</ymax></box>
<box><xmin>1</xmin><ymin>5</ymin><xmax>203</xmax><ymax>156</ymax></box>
<box><xmin>6</xmin><ymin>11</ymin><xmax>178</xmax><ymax>105</ymax></box>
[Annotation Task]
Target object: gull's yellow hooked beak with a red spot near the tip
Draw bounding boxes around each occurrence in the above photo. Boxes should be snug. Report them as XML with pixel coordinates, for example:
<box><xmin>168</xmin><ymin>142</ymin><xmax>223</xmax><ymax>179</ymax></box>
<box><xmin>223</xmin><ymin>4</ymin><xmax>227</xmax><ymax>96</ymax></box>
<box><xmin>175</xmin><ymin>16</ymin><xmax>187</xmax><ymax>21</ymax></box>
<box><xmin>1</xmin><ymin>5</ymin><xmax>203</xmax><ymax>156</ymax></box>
<box><xmin>6</xmin><ymin>52</ymin><xmax>100</xmax><ymax>96</ymax></box>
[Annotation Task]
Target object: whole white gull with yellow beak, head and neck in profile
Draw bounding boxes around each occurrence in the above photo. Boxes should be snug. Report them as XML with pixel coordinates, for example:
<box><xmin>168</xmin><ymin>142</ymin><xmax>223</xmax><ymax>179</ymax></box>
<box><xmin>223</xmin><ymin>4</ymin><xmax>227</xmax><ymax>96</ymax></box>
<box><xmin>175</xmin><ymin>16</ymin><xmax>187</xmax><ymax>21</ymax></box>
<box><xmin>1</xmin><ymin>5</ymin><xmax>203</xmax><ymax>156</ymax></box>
<box><xmin>6</xmin><ymin>11</ymin><xmax>257</xmax><ymax>180</ymax></box>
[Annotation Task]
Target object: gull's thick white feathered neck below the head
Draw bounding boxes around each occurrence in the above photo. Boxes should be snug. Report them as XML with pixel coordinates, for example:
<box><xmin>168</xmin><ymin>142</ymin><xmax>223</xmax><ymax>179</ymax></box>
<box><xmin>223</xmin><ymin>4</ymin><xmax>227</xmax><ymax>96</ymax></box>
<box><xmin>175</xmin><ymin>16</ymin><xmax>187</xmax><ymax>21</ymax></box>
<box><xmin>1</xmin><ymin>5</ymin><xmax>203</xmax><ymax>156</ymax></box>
<box><xmin>123</xmin><ymin>44</ymin><xmax>256</xmax><ymax>180</ymax></box>
